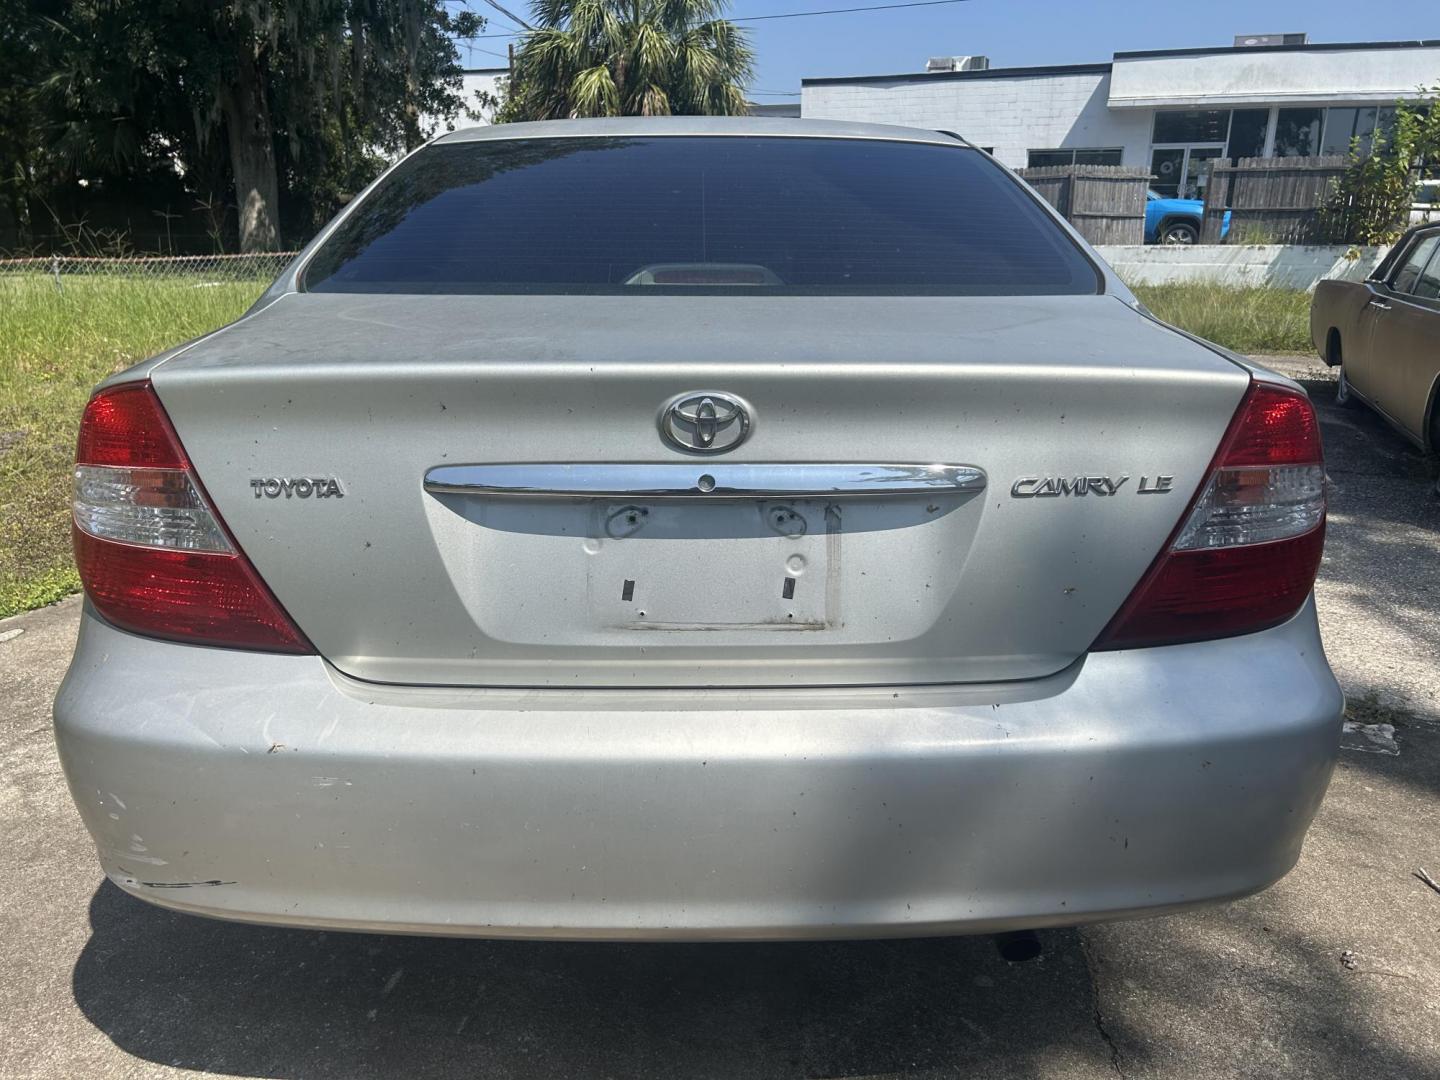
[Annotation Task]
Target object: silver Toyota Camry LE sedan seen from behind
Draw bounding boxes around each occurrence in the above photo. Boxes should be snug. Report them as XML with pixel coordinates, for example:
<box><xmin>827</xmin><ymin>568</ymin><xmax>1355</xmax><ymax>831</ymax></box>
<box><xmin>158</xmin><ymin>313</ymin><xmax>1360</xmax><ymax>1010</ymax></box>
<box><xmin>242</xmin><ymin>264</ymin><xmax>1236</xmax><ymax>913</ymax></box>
<box><xmin>55</xmin><ymin>118</ymin><xmax>1342</xmax><ymax>939</ymax></box>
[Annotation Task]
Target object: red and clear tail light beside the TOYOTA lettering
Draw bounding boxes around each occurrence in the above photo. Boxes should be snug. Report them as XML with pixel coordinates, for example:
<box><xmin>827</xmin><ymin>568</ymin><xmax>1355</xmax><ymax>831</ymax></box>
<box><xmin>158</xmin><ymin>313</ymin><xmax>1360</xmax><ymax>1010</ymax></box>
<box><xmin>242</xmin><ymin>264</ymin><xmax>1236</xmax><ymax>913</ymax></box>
<box><xmin>72</xmin><ymin>382</ymin><xmax>314</xmax><ymax>652</ymax></box>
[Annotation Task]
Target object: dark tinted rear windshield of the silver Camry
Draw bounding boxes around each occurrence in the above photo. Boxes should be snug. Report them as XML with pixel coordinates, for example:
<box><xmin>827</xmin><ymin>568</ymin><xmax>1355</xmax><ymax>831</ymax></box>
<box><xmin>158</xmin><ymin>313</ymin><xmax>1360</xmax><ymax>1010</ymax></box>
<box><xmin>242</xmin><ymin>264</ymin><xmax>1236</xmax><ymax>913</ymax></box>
<box><xmin>305</xmin><ymin>135</ymin><xmax>1099</xmax><ymax>295</ymax></box>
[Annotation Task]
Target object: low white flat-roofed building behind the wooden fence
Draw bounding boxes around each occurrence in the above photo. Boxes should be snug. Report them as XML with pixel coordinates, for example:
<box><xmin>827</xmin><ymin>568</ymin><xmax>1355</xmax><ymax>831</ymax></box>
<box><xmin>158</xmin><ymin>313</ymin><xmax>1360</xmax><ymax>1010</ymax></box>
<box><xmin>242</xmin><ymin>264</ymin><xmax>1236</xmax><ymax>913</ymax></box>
<box><xmin>801</xmin><ymin>35</ymin><xmax>1440</xmax><ymax>197</ymax></box>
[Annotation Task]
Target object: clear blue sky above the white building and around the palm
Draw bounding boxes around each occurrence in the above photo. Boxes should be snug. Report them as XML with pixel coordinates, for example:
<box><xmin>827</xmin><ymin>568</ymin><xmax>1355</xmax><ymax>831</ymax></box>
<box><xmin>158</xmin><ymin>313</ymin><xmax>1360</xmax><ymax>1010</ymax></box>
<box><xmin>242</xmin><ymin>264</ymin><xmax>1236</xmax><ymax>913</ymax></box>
<box><xmin>462</xmin><ymin>0</ymin><xmax>1440</xmax><ymax>104</ymax></box>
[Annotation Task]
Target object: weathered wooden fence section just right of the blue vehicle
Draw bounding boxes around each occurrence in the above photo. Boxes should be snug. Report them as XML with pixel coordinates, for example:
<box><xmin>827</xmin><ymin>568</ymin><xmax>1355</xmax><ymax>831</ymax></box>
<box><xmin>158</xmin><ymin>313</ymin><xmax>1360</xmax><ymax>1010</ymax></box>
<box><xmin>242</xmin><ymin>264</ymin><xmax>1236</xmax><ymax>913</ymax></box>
<box><xmin>1200</xmin><ymin>154</ymin><xmax>1349</xmax><ymax>243</ymax></box>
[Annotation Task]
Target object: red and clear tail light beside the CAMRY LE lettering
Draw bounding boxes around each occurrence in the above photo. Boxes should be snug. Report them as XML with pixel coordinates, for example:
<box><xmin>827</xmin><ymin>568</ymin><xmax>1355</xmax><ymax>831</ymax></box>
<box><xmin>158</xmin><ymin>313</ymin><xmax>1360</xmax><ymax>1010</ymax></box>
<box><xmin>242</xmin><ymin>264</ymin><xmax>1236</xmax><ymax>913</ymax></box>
<box><xmin>1094</xmin><ymin>383</ymin><xmax>1325</xmax><ymax>649</ymax></box>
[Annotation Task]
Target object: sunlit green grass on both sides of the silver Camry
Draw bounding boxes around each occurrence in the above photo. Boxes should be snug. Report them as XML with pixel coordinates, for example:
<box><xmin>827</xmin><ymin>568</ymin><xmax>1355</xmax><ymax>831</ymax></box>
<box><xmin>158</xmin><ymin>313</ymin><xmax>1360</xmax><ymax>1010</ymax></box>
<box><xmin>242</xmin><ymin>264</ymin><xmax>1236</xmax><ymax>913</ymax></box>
<box><xmin>0</xmin><ymin>275</ymin><xmax>1310</xmax><ymax>616</ymax></box>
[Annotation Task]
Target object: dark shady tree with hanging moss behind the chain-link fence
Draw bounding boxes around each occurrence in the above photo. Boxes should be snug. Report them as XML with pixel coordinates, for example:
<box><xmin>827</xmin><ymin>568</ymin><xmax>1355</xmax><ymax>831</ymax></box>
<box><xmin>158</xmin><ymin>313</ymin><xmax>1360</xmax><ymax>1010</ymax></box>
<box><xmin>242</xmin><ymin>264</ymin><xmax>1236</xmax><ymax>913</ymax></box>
<box><xmin>0</xmin><ymin>0</ymin><xmax>484</xmax><ymax>251</ymax></box>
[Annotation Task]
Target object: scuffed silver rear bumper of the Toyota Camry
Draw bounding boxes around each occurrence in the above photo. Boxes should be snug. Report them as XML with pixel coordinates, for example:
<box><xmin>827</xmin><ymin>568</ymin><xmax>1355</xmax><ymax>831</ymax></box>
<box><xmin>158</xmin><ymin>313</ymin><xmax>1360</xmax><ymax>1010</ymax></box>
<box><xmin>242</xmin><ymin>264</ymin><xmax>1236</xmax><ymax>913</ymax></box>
<box><xmin>55</xmin><ymin>605</ymin><xmax>1344</xmax><ymax>939</ymax></box>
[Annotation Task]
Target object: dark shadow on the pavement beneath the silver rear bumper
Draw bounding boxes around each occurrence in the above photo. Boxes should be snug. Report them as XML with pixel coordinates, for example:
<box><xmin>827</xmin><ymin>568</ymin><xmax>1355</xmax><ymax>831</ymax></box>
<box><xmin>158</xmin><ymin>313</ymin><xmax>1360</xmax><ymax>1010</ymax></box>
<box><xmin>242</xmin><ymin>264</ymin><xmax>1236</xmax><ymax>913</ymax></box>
<box><xmin>73</xmin><ymin>881</ymin><xmax>1113</xmax><ymax>1079</ymax></box>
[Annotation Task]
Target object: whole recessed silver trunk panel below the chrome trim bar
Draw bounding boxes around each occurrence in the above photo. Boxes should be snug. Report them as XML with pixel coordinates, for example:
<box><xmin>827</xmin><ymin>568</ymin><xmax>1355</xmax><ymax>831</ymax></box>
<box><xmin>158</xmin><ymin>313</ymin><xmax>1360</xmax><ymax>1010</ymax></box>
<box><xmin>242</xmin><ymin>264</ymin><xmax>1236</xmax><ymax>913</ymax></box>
<box><xmin>418</xmin><ymin>492</ymin><xmax>981</xmax><ymax>656</ymax></box>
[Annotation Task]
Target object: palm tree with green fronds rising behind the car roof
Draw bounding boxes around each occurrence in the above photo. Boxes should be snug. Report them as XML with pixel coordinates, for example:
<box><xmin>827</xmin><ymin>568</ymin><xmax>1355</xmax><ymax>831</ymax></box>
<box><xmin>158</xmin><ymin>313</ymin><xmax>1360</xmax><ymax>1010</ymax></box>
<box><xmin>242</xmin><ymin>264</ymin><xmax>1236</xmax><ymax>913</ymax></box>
<box><xmin>500</xmin><ymin>0</ymin><xmax>755</xmax><ymax>121</ymax></box>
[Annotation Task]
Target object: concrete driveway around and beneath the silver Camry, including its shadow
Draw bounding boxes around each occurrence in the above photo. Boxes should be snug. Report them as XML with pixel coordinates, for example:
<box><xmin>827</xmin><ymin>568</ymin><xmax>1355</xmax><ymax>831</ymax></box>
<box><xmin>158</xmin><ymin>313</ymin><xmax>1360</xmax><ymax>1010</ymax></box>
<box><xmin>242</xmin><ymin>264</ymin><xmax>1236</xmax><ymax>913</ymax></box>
<box><xmin>0</xmin><ymin>360</ymin><xmax>1440</xmax><ymax>1080</ymax></box>
